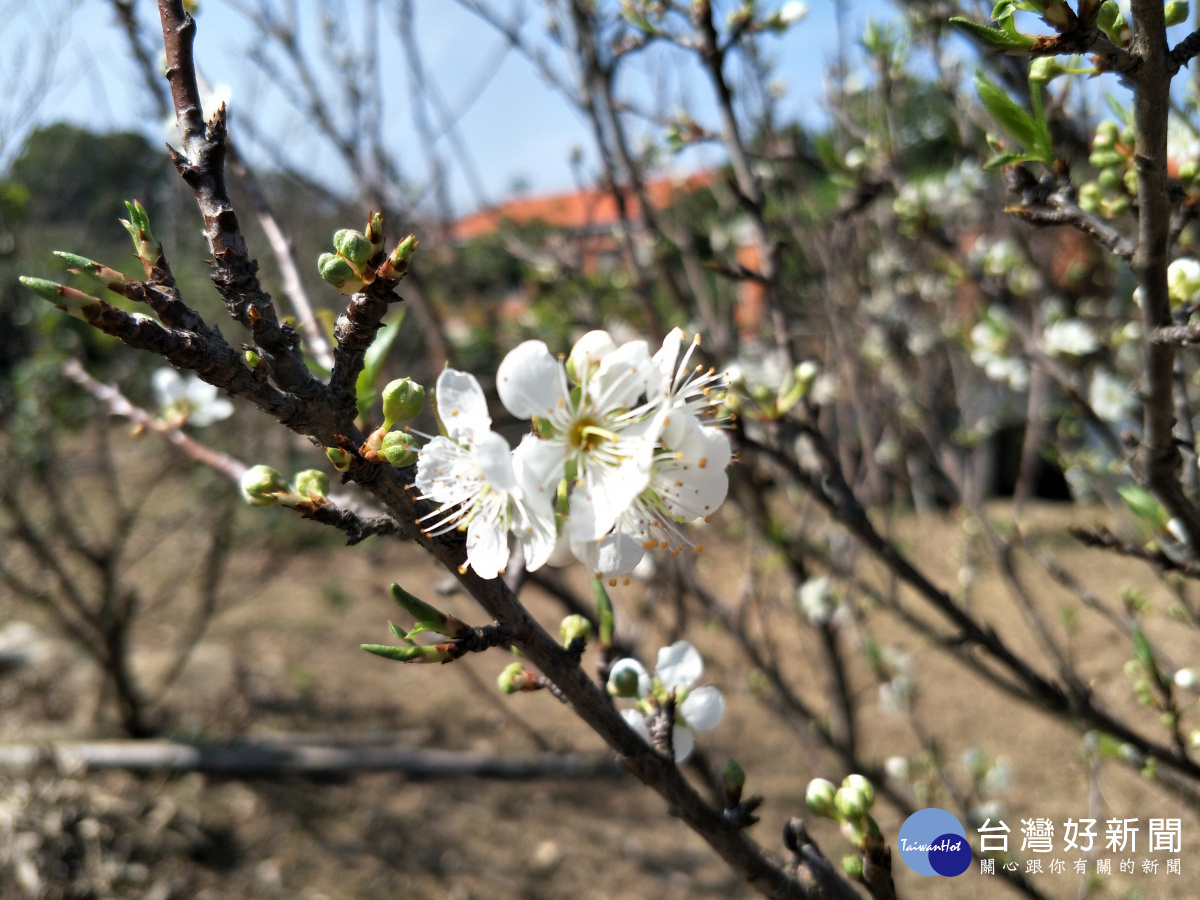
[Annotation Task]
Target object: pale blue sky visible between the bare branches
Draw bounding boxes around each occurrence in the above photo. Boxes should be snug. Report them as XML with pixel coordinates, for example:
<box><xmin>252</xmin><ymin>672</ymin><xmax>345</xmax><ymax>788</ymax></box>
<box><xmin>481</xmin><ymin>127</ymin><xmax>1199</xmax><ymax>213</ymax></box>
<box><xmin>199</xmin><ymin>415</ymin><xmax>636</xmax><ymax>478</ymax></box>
<box><xmin>0</xmin><ymin>0</ymin><xmax>890</xmax><ymax>212</ymax></box>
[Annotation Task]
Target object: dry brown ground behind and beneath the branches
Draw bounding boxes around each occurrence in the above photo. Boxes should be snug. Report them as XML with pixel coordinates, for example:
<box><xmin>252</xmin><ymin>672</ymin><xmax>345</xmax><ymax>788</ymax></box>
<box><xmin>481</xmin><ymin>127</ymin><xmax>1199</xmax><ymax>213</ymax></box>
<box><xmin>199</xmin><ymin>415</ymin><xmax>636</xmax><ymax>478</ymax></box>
<box><xmin>0</xmin><ymin>468</ymin><xmax>1200</xmax><ymax>900</ymax></box>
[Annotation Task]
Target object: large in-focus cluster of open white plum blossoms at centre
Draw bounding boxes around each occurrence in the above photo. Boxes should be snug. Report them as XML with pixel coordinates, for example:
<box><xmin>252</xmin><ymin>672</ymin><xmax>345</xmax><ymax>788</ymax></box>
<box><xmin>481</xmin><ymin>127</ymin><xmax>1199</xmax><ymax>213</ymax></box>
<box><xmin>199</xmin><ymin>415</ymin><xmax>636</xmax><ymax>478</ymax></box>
<box><xmin>416</xmin><ymin>329</ymin><xmax>731</xmax><ymax>578</ymax></box>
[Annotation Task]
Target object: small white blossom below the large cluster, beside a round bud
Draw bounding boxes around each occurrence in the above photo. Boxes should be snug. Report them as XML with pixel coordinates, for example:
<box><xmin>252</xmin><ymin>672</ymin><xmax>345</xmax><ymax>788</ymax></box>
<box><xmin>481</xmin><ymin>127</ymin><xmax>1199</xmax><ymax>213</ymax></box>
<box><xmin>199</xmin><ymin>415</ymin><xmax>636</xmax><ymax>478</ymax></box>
<box><xmin>608</xmin><ymin>641</ymin><xmax>725</xmax><ymax>762</ymax></box>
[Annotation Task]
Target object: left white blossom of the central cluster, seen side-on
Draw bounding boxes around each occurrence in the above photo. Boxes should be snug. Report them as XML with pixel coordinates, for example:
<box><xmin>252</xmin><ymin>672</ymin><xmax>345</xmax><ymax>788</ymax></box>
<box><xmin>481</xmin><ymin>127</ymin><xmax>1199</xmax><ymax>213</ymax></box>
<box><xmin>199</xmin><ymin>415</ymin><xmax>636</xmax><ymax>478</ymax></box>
<box><xmin>416</xmin><ymin>368</ymin><xmax>557</xmax><ymax>578</ymax></box>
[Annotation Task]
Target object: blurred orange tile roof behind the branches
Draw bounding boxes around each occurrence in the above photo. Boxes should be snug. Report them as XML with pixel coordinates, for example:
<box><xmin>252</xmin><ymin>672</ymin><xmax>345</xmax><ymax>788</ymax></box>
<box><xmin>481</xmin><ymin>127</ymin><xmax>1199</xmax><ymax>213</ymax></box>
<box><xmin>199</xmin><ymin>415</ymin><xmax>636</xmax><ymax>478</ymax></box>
<box><xmin>451</xmin><ymin>170</ymin><xmax>716</xmax><ymax>241</ymax></box>
